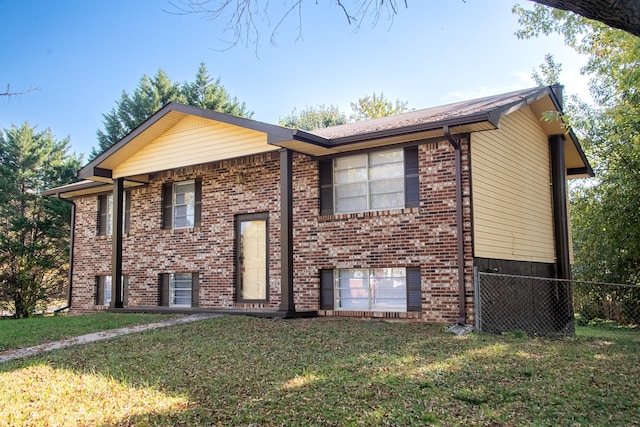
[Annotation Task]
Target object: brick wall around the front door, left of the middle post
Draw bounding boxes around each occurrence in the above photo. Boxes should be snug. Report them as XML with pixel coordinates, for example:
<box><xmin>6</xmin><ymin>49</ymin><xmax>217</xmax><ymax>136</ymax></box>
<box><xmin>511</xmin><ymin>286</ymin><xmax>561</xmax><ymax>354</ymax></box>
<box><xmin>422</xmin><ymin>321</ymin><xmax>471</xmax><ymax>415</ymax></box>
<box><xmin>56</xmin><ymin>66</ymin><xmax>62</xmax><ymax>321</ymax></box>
<box><xmin>72</xmin><ymin>153</ymin><xmax>280</xmax><ymax>312</ymax></box>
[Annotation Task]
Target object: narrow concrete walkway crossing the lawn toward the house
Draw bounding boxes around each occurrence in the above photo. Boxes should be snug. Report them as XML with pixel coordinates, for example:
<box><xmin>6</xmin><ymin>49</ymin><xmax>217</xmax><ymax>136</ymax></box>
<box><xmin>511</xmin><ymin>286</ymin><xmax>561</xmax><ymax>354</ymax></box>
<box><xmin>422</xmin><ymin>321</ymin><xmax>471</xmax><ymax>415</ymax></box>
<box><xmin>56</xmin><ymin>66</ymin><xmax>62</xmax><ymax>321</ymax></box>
<box><xmin>0</xmin><ymin>313</ymin><xmax>221</xmax><ymax>363</ymax></box>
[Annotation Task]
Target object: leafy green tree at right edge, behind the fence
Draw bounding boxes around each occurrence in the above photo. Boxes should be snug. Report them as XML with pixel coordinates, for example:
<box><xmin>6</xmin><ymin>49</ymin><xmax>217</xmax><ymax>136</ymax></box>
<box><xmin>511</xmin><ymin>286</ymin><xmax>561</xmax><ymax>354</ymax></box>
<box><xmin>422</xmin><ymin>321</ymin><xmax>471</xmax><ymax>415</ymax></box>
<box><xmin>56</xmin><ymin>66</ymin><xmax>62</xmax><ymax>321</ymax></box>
<box><xmin>515</xmin><ymin>6</ymin><xmax>640</xmax><ymax>284</ymax></box>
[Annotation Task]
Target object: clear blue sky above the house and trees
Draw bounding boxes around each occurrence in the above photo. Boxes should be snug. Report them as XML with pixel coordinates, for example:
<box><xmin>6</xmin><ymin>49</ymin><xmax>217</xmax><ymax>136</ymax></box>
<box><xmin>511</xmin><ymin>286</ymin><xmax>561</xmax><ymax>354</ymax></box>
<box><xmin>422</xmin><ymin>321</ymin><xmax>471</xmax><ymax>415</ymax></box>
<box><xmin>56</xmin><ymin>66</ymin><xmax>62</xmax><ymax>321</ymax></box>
<box><xmin>0</xmin><ymin>0</ymin><xmax>587</xmax><ymax>158</ymax></box>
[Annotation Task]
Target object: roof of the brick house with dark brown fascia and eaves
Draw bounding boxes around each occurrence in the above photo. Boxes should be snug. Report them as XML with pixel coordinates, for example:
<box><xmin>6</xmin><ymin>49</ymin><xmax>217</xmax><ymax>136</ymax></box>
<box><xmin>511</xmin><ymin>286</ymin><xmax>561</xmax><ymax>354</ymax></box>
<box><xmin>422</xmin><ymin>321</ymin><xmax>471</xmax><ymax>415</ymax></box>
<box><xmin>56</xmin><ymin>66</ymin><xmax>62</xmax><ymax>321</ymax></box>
<box><xmin>49</xmin><ymin>86</ymin><xmax>593</xmax><ymax>196</ymax></box>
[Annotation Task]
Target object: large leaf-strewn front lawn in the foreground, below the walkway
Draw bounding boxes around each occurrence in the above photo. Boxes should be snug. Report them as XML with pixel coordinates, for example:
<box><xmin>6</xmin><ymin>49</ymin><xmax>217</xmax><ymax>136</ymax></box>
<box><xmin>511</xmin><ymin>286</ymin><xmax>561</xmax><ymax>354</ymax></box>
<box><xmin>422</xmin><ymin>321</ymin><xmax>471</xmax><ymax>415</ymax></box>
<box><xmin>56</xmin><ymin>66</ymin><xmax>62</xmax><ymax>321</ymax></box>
<box><xmin>0</xmin><ymin>316</ymin><xmax>640</xmax><ymax>426</ymax></box>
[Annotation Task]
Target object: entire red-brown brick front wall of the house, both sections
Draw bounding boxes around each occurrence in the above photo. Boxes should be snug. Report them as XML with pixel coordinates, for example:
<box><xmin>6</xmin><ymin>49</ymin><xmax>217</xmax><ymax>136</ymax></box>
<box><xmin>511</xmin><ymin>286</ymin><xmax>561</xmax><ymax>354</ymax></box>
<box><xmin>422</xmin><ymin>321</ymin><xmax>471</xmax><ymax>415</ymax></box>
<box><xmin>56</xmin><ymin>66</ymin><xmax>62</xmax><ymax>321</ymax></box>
<box><xmin>73</xmin><ymin>142</ymin><xmax>473</xmax><ymax>323</ymax></box>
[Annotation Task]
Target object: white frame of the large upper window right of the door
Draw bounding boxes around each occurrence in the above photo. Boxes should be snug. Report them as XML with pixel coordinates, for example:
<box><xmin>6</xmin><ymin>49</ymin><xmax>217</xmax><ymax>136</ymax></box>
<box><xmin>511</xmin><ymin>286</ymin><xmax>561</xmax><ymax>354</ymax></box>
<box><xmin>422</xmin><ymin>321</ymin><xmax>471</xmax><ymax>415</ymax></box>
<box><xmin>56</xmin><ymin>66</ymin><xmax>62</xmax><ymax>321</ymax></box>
<box><xmin>333</xmin><ymin>148</ymin><xmax>405</xmax><ymax>214</ymax></box>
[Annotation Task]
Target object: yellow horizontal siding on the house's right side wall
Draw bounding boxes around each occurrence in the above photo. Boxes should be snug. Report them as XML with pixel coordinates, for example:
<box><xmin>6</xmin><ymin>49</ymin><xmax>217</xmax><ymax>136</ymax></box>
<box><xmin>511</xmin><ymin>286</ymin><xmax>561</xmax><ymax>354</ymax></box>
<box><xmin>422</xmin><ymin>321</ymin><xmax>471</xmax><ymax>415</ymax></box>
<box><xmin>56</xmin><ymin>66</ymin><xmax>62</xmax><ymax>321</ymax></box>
<box><xmin>471</xmin><ymin>107</ymin><xmax>555</xmax><ymax>262</ymax></box>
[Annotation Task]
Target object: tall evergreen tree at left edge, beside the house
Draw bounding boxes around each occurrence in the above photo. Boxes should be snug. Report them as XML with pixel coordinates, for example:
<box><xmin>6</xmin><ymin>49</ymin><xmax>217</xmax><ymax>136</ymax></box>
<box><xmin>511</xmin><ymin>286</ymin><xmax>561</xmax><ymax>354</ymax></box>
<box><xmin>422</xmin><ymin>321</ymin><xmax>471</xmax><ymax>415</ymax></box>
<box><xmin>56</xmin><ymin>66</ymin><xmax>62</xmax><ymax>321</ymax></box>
<box><xmin>0</xmin><ymin>123</ymin><xmax>81</xmax><ymax>318</ymax></box>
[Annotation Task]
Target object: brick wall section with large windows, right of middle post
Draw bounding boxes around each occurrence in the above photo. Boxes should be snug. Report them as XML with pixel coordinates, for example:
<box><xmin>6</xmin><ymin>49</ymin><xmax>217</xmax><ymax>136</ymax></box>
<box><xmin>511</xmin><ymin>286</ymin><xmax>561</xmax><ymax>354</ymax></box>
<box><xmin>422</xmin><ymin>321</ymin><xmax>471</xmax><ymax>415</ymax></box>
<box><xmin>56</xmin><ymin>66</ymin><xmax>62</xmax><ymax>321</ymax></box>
<box><xmin>293</xmin><ymin>140</ymin><xmax>473</xmax><ymax>323</ymax></box>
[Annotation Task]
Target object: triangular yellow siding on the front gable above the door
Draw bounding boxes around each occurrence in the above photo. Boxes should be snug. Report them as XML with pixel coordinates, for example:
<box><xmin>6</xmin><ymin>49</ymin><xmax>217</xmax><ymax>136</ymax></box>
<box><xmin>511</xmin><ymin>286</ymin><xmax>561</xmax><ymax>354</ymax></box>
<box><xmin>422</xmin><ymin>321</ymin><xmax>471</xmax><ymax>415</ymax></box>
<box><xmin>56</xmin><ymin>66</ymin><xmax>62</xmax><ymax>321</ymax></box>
<box><xmin>113</xmin><ymin>116</ymin><xmax>277</xmax><ymax>178</ymax></box>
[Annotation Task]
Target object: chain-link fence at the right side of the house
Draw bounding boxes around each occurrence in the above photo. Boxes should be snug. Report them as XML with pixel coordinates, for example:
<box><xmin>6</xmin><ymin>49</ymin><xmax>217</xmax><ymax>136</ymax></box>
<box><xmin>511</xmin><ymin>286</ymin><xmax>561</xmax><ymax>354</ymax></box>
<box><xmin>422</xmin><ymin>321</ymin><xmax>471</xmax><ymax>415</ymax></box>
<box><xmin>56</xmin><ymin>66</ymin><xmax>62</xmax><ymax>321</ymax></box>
<box><xmin>474</xmin><ymin>271</ymin><xmax>640</xmax><ymax>336</ymax></box>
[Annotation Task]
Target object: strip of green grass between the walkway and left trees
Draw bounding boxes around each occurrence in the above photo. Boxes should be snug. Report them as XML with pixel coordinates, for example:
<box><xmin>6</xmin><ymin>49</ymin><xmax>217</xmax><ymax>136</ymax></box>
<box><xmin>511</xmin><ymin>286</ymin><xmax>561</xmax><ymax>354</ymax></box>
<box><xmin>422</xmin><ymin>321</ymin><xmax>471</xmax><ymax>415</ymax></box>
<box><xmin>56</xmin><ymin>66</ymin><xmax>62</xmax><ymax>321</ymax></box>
<box><xmin>0</xmin><ymin>312</ymin><xmax>181</xmax><ymax>352</ymax></box>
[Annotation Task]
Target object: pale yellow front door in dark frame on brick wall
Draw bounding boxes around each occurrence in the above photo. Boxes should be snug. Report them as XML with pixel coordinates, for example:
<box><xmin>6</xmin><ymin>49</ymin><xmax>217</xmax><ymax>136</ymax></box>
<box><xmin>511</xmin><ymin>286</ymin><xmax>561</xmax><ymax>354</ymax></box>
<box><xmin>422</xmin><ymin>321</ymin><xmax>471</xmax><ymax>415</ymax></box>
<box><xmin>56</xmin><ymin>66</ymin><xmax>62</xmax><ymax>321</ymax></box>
<box><xmin>236</xmin><ymin>213</ymin><xmax>268</xmax><ymax>301</ymax></box>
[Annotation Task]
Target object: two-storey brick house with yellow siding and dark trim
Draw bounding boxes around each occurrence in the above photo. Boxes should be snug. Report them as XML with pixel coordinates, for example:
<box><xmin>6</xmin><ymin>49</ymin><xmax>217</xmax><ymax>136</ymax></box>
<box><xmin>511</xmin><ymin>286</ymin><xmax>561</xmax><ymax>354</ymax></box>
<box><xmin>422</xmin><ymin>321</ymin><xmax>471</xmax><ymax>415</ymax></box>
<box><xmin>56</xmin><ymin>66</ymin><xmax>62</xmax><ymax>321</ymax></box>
<box><xmin>48</xmin><ymin>86</ymin><xmax>592</xmax><ymax>323</ymax></box>
